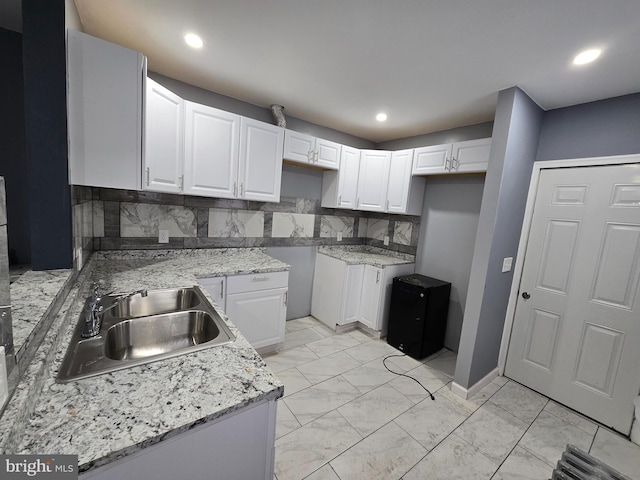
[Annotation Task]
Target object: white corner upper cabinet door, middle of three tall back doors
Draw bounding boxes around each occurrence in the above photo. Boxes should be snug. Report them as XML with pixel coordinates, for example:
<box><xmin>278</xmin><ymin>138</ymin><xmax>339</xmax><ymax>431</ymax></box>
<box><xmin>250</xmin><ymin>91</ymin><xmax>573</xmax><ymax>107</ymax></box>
<box><xmin>356</xmin><ymin>150</ymin><xmax>391</xmax><ymax>212</ymax></box>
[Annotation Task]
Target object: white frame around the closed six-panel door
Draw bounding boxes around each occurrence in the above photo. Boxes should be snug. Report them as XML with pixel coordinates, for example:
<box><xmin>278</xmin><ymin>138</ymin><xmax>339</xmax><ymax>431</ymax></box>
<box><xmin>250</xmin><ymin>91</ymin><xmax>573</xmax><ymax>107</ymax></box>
<box><xmin>498</xmin><ymin>154</ymin><xmax>640</xmax><ymax>375</ymax></box>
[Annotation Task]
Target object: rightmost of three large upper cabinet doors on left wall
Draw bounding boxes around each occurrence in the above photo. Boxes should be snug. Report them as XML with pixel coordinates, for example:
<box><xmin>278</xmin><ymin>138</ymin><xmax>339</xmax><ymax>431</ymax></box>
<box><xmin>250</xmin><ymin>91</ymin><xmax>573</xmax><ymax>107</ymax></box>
<box><xmin>238</xmin><ymin>121</ymin><xmax>284</xmax><ymax>202</ymax></box>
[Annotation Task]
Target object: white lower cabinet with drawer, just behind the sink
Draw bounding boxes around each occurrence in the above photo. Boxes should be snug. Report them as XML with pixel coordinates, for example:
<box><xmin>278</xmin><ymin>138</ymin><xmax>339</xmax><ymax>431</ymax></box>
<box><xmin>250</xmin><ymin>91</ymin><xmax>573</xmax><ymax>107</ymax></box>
<box><xmin>198</xmin><ymin>271</ymin><xmax>289</xmax><ymax>353</ymax></box>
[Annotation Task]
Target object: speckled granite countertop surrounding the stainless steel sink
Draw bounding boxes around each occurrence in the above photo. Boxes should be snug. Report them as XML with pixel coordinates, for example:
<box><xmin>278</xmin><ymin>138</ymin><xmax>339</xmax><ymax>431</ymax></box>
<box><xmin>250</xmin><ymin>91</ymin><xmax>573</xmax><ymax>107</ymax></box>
<box><xmin>5</xmin><ymin>249</ymin><xmax>289</xmax><ymax>472</ymax></box>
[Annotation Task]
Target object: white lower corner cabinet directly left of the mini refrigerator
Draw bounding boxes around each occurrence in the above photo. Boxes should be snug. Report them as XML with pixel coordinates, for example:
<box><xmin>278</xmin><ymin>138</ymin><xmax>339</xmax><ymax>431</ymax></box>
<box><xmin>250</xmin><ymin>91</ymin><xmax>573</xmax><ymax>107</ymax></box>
<box><xmin>311</xmin><ymin>253</ymin><xmax>415</xmax><ymax>336</ymax></box>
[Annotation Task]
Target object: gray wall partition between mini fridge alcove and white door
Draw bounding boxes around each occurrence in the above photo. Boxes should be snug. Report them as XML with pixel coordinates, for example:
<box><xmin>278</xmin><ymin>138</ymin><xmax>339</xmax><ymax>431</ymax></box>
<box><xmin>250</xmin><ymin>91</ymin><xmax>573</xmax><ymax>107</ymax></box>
<box><xmin>454</xmin><ymin>87</ymin><xmax>543</xmax><ymax>388</ymax></box>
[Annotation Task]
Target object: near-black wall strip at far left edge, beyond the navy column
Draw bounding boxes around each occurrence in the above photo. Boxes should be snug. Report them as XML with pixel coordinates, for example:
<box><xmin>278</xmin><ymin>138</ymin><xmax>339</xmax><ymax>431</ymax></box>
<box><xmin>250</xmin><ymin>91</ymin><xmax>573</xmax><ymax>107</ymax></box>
<box><xmin>0</xmin><ymin>28</ymin><xmax>31</xmax><ymax>264</ymax></box>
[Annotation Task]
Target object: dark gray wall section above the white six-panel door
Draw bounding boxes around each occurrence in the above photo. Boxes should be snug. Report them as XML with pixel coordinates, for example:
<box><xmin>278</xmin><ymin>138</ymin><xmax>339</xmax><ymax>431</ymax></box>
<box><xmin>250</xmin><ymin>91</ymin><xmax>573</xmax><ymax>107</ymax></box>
<box><xmin>536</xmin><ymin>93</ymin><xmax>640</xmax><ymax>160</ymax></box>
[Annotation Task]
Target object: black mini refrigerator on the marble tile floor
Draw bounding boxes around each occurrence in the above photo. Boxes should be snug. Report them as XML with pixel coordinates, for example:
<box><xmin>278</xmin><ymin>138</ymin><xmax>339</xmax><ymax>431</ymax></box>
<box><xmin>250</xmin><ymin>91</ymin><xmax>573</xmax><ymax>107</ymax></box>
<box><xmin>387</xmin><ymin>273</ymin><xmax>451</xmax><ymax>359</ymax></box>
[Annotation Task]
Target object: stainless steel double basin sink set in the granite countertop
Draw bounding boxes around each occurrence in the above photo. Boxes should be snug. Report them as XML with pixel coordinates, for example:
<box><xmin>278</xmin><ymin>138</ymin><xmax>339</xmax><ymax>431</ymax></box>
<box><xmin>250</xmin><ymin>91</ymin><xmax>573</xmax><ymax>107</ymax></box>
<box><xmin>56</xmin><ymin>287</ymin><xmax>235</xmax><ymax>383</ymax></box>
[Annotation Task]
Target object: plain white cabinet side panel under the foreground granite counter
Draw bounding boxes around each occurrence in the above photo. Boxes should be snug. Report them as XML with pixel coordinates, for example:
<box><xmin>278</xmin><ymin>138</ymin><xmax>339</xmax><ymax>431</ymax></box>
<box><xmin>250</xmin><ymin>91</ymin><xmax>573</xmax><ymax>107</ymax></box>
<box><xmin>80</xmin><ymin>400</ymin><xmax>277</xmax><ymax>480</ymax></box>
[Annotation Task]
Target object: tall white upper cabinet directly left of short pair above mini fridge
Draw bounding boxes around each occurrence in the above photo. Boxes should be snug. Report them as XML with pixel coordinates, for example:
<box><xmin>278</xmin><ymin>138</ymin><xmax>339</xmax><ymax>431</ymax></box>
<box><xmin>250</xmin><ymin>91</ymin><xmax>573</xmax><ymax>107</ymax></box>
<box><xmin>386</xmin><ymin>149</ymin><xmax>425</xmax><ymax>215</ymax></box>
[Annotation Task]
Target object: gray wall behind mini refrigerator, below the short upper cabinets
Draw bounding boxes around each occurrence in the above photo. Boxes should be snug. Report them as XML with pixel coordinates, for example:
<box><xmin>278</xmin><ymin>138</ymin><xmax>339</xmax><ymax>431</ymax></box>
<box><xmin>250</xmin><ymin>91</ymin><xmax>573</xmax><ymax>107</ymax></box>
<box><xmin>416</xmin><ymin>175</ymin><xmax>484</xmax><ymax>351</ymax></box>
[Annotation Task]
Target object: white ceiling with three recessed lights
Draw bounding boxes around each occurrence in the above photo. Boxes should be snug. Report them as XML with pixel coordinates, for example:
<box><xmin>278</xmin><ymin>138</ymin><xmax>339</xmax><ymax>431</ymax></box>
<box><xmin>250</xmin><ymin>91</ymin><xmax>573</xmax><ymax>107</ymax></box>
<box><xmin>7</xmin><ymin>0</ymin><xmax>640</xmax><ymax>142</ymax></box>
